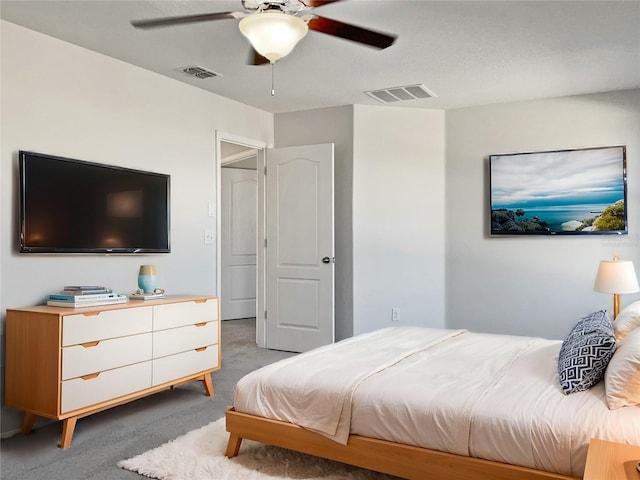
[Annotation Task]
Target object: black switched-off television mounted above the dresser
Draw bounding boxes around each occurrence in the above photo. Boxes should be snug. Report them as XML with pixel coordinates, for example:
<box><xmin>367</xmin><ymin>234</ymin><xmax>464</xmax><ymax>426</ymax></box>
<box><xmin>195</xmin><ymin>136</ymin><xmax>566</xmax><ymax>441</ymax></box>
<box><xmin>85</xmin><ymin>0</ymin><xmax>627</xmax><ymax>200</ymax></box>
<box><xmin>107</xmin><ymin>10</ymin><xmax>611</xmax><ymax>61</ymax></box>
<box><xmin>19</xmin><ymin>151</ymin><xmax>171</xmax><ymax>253</ymax></box>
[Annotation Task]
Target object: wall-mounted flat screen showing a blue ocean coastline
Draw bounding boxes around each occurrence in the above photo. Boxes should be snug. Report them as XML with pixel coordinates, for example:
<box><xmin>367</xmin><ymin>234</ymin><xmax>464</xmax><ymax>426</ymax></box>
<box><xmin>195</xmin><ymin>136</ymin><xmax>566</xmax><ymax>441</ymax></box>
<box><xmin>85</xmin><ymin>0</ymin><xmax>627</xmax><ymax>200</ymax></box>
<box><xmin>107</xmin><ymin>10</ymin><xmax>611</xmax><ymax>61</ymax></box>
<box><xmin>489</xmin><ymin>146</ymin><xmax>628</xmax><ymax>235</ymax></box>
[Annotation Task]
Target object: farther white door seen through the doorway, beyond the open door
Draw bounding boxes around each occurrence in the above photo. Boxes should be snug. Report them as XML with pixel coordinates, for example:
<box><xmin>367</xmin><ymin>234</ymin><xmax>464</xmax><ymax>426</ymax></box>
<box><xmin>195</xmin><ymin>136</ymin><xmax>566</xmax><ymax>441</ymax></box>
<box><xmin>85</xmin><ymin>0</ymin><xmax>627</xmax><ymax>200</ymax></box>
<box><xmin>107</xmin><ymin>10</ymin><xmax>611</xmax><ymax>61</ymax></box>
<box><xmin>220</xmin><ymin>168</ymin><xmax>258</xmax><ymax>320</ymax></box>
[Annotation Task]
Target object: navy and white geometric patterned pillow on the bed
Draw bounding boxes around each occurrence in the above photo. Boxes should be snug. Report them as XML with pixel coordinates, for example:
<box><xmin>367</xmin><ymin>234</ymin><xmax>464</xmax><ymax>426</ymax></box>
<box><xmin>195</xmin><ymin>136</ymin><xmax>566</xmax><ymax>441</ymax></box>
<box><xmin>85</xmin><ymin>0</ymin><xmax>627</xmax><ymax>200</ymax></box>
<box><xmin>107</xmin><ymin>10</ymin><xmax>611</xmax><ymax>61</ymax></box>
<box><xmin>558</xmin><ymin>310</ymin><xmax>616</xmax><ymax>395</ymax></box>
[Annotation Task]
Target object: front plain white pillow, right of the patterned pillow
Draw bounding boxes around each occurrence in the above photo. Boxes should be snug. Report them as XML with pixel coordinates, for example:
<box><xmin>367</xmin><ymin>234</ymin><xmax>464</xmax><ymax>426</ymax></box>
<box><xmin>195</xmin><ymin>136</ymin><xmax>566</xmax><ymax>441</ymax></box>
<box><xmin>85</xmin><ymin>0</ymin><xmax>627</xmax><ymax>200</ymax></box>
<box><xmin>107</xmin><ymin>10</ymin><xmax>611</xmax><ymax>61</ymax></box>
<box><xmin>604</xmin><ymin>328</ymin><xmax>640</xmax><ymax>410</ymax></box>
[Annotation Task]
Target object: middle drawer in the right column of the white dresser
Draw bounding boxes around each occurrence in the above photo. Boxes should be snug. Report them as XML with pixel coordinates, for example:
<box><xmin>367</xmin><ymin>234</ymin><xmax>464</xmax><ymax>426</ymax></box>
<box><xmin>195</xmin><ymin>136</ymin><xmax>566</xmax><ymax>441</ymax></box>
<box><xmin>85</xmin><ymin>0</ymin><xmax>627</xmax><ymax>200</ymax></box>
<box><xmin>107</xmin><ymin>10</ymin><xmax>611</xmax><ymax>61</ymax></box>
<box><xmin>153</xmin><ymin>322</ymin><xmax>218</xmax><ymax>358</ymax></box>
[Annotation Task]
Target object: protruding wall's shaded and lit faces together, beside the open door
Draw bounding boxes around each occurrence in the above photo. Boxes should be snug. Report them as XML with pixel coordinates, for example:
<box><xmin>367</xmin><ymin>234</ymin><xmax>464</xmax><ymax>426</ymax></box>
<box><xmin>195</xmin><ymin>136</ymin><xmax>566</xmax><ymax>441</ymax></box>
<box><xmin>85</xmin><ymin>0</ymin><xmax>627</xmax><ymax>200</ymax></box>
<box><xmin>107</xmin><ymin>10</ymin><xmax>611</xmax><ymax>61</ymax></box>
<box><xmin>275</xmin><ymin>105</ymin><xmax>445</xmax><ymax>339</ymax></box>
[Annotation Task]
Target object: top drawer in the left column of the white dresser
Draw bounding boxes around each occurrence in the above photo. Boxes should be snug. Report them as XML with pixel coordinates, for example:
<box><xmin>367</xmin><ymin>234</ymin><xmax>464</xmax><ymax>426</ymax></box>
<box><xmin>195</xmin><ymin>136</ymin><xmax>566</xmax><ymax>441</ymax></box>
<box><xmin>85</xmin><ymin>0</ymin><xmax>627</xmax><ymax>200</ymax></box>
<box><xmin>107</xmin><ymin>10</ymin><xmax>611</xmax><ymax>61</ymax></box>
<box><xmin>62</xmin><ymin>307</ymin><xmax>153</xmax><ymax>347</ymax></box>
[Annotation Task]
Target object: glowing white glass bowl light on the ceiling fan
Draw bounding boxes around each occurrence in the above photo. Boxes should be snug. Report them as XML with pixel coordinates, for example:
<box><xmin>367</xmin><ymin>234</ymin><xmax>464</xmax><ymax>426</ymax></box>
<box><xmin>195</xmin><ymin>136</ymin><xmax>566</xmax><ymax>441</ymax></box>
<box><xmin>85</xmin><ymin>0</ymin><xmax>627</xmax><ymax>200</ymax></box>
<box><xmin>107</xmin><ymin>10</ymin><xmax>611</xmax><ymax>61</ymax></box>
<box><xmin>238</xmin><ymin>11</ymin><xmax>309</xmax><ymax>63</ymax></box>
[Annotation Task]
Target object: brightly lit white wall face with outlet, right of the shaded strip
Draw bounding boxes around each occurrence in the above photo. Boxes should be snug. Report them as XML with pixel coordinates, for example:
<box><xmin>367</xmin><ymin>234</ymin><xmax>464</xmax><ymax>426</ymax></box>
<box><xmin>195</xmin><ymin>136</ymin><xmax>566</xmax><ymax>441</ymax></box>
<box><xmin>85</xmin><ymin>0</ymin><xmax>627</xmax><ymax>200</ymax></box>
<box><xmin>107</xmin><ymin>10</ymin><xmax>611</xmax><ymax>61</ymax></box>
<box><xmin>353</xmin><ymin>105</ymin><xmax>445</xmax><ymax>334</ymax></box>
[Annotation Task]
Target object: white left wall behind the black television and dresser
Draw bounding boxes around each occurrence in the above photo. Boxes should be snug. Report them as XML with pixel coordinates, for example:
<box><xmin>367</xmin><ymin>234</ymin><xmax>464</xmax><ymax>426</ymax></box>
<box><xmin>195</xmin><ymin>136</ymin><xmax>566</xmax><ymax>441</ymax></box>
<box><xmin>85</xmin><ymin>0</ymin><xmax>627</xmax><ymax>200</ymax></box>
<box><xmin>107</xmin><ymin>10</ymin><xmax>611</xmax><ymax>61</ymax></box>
<box><xmin>0</xmin><ymin>21</ymin><xmax>273</xmax><ymax>433</ymax></box>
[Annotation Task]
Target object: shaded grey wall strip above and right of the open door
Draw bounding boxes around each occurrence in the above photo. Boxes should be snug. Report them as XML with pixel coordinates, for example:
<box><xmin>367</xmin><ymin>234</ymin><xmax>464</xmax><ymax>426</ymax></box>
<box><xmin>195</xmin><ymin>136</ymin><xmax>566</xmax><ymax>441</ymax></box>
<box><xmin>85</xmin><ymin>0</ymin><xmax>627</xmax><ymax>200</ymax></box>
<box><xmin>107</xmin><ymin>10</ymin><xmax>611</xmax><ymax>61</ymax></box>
<box><xmin>275</xmin><ymin>106</ymin><xmax>353</xmax><ymax>340</ymax></box>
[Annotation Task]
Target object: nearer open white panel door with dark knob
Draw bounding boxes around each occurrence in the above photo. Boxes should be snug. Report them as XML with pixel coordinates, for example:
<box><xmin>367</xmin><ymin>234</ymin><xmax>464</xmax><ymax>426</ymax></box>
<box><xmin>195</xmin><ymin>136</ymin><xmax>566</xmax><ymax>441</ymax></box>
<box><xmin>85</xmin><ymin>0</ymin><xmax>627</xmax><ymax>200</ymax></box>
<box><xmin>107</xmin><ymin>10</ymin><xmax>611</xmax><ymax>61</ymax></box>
<box><xmin>265</xmin><ymin>144</ymin><xmax>334</xmax><ymax>352</ymax></box>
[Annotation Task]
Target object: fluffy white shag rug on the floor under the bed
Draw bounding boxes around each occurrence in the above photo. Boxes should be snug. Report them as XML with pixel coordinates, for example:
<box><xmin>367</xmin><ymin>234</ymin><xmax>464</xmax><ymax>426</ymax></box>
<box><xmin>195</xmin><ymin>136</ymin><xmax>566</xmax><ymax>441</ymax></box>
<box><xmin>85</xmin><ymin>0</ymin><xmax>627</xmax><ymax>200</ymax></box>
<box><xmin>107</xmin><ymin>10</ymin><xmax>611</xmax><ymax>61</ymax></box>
<box><xmin>118</xmin><ymin>418</ymin><xmax>396</xmax><ymax>480</ymax></box>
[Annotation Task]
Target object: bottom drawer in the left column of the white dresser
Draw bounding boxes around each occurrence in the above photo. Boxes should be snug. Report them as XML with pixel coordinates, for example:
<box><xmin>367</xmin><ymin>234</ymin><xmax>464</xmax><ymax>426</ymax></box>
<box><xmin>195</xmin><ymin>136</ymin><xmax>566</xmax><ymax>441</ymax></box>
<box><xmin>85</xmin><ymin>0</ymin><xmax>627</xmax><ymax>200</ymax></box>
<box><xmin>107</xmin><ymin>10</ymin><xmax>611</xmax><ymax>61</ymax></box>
<box><xmin>61</xmin><ymin>361</ymin><xmax>151</xmax><ymax>413</ymax></box>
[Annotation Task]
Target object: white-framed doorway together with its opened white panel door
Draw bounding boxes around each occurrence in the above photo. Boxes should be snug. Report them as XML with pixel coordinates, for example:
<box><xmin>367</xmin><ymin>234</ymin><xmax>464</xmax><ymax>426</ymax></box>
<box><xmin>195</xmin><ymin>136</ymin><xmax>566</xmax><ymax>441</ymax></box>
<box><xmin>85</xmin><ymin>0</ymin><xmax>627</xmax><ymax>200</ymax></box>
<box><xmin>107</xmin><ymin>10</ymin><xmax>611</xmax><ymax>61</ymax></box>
<box><xmin>216</xmin><ymin>133</ymin><xmax>335</xmax><ymax>352</ymax></box>
